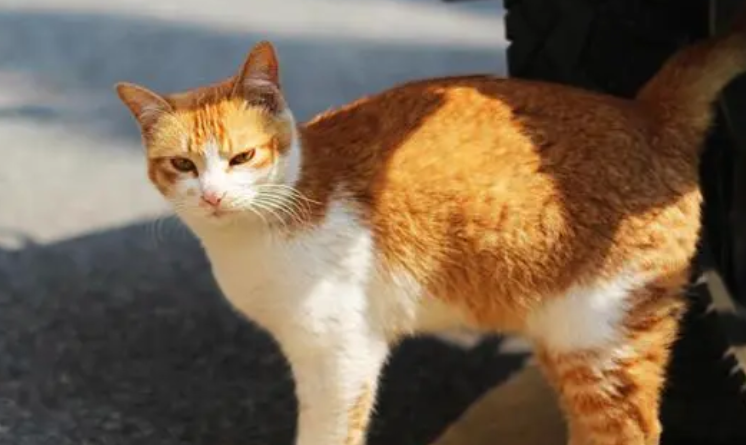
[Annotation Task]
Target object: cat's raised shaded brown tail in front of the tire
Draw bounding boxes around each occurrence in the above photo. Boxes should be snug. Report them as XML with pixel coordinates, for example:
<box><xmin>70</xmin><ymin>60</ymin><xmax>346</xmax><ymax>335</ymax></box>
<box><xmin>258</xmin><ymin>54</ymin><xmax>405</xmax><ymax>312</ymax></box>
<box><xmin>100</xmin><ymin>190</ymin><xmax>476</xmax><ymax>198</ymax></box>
<box><xmin>636</xmin><ymin>7</ymin><xmax>746</xmax><ymax>153</ymax></box>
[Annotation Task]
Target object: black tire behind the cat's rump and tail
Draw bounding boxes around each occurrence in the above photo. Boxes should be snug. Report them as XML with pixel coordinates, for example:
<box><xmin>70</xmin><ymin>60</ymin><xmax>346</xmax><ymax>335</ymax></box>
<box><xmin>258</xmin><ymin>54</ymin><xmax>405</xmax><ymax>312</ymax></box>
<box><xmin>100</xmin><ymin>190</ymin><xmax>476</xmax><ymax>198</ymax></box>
<box><xmin>504</xmin><ymin>0</ymin><xmax>746</xmax><ymax>445</ymax></box>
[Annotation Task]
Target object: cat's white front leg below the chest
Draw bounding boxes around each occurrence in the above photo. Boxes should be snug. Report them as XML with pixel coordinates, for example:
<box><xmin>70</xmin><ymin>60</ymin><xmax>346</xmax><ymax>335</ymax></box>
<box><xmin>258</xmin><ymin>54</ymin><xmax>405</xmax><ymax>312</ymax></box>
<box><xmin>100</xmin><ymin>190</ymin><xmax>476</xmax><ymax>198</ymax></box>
<box><xmin>278</xmin><ymin>294</ymin><xmax>389</xmax><ymax>445</ymax></box>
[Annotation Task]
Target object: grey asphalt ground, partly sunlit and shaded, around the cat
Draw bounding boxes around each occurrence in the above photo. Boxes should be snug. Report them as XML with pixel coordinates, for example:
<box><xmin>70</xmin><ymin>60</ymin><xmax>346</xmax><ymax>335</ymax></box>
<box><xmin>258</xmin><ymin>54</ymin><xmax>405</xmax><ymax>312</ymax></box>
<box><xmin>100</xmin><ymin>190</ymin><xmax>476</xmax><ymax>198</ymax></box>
<box><xmin>0</xmin><ymin>0</ymin><xmax>522</xmax><ymax>445</ymax></box>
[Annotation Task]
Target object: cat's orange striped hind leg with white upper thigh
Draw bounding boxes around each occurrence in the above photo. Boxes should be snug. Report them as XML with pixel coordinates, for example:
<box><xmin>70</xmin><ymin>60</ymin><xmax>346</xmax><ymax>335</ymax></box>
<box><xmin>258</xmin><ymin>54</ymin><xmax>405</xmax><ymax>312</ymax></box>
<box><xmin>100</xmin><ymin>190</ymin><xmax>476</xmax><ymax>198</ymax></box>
<box><xmin>531</xmin><ymin>279</ymin><xmax>683</xmax><ymax>445</ymax></box>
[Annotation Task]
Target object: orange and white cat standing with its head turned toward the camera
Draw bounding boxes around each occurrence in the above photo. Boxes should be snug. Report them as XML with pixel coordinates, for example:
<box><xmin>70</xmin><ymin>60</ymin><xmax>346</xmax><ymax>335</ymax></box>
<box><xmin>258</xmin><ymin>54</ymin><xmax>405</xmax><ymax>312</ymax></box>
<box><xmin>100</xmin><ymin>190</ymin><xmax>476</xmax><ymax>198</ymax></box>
<box><xmin>117</xmin><ymin>9</ymin><xmax>746</xmax><ymax>445</ymax></box>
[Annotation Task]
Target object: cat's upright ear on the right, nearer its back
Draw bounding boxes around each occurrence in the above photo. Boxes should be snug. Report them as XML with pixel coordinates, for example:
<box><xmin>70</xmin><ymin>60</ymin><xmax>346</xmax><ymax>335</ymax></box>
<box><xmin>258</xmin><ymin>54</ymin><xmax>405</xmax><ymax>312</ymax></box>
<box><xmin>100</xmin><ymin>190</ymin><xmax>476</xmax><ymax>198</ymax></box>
<box><xmin>233</xmin><ymin>41</ymin><xmax>283</xmax><ymax>112</ymax></box>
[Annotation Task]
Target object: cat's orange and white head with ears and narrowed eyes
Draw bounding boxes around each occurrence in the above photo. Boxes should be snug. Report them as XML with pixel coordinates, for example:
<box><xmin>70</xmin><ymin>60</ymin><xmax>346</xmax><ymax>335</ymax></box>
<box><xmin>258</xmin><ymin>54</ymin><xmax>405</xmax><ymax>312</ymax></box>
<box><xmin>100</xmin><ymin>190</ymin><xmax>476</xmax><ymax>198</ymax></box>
<box><xmin>116</xmin><ymin>42</ymin><xmax>299</xmax><ymax>224</ymax></box>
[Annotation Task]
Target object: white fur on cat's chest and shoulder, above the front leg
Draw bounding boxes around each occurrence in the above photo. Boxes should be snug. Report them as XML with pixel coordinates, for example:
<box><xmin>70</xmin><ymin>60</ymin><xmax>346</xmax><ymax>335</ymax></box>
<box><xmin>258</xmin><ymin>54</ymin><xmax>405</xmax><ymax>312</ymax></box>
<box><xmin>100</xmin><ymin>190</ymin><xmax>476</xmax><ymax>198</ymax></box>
<box><xmin>189</xmin><ymin>203</ymin><xmax>456</xmax><ymax>340</ymax></box>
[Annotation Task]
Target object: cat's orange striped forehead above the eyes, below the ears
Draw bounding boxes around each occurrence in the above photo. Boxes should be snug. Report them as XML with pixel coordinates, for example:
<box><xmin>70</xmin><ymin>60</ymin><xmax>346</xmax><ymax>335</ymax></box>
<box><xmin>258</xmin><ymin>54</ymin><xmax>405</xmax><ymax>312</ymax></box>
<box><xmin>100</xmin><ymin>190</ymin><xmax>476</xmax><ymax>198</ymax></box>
<box><xmin>151</xmin><ymin>100</ymin><xmax>289</xmax><ymax>156</ymax></box>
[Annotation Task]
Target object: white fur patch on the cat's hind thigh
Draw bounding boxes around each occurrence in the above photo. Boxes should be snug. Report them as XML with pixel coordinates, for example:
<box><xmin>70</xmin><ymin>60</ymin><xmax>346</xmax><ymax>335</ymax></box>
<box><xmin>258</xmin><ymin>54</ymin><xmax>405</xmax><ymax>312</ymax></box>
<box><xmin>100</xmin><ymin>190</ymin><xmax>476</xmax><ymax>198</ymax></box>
<box><xmin>527</xmin><ymin>274</ymin><xmax>644</xmax><ymax>352</ymax></box>
